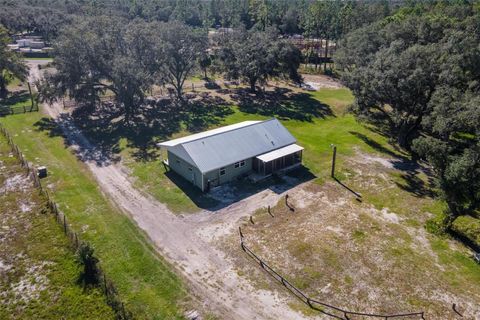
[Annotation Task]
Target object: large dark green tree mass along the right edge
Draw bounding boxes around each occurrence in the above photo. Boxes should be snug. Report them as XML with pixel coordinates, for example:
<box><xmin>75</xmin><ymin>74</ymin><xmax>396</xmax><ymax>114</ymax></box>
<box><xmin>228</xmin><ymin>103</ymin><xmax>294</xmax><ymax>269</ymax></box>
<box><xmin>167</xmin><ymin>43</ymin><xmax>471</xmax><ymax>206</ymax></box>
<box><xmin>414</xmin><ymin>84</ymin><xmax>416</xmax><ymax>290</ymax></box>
<box><xmin>335</xmin><ymin>3</ymin><xmax>480</xmax><ymax>230</ymax></box>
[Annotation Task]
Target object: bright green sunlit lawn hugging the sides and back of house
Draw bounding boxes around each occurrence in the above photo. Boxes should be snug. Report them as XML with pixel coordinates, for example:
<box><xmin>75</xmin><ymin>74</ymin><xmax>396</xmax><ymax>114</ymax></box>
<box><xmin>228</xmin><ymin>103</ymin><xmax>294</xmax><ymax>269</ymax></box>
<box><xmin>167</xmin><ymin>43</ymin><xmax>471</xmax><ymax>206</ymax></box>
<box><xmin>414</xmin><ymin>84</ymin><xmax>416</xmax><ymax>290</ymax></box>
<box><xmin>120</xmin><ymin>89</ymin><xmax>394</xmax><ymax>213</ymax></box>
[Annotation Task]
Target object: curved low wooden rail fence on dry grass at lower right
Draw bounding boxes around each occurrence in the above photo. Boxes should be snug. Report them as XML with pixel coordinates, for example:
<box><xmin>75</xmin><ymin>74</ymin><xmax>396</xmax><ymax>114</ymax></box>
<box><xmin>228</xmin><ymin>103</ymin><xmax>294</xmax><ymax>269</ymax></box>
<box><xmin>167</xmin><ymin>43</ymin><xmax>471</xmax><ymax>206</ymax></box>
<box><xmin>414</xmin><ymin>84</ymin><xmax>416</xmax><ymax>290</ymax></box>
<box><xmin>238</xmin><ymin>227</ymin><xmax>425</xmax><ymax>320</ymax></box>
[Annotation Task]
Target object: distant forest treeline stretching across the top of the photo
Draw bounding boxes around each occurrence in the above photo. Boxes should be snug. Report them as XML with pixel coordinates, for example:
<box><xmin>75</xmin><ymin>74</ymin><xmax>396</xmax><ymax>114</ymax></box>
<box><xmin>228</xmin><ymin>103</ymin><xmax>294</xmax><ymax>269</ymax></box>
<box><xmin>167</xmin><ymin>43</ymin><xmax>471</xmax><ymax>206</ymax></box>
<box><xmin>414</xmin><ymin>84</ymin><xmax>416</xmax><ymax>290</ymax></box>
<box><xmin>0</xmin><ymin>0</ymin><xmax>398</xmax><ymax>40</ymax></box>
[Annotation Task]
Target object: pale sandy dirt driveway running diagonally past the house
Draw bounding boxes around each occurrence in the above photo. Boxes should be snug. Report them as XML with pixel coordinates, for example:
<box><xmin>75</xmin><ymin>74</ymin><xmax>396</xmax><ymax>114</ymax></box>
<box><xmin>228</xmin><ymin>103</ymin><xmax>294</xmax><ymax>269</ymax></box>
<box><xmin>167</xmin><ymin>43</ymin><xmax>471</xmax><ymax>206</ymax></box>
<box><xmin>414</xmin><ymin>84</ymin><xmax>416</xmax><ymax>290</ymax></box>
<box><xmin>25</xmin><ymin>61</ymin><xmax>308</xmax><ymax>319</ymax></box>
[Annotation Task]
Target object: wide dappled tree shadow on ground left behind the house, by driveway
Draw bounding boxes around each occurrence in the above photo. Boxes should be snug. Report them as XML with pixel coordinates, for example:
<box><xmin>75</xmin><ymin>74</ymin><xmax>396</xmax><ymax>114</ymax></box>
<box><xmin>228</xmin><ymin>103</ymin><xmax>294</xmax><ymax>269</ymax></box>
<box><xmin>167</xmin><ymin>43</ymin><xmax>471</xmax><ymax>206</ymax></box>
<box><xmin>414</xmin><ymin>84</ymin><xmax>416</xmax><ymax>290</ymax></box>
<box><xmin>35</xmin><ymin>94</ymin><xmax>233</xmax><ymax>165</ymax></box>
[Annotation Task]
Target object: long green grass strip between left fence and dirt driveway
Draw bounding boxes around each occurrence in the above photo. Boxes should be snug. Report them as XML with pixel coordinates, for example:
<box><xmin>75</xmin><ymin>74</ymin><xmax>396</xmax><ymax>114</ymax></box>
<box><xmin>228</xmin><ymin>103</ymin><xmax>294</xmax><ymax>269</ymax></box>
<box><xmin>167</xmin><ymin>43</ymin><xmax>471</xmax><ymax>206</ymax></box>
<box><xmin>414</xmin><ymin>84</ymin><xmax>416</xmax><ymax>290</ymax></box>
<box><xmin>0</xmin><ymin>109</ymin><xmax>188</xmax><ymax>319</ymax></box>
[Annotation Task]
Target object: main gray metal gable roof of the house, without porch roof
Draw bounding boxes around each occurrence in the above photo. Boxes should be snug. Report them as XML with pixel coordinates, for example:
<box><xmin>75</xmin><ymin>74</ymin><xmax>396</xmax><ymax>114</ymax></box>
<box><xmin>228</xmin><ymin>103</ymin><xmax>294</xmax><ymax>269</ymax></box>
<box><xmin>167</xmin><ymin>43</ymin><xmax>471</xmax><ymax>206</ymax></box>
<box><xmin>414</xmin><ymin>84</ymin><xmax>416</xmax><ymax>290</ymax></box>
<box><xmin>159</xmin><ymin>119</ymin><xmax>296</xmax><ymax>173</ymax></box>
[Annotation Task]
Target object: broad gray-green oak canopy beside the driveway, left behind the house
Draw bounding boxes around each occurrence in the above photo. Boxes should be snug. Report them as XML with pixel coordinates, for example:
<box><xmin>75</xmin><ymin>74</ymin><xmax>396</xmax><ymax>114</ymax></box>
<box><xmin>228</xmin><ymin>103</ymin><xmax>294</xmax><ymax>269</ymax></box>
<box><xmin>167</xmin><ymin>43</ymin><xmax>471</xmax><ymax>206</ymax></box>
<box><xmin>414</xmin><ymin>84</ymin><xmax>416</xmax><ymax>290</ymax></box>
<box><xmin>40</xmin><ymin>16</ymin><xmax>206</xmax><ymax>122</ymax></box>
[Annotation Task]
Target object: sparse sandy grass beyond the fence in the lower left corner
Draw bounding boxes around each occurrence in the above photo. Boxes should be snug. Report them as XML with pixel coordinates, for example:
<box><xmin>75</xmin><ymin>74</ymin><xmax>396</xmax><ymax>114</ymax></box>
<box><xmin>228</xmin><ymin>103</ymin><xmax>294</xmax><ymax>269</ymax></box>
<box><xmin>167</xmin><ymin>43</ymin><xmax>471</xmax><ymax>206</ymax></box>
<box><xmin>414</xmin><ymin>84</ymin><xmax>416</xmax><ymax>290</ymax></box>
<box><xmin>0</xmin><ymin>136</ymin><xmax>114</xmax><ymax>319</ymax></box>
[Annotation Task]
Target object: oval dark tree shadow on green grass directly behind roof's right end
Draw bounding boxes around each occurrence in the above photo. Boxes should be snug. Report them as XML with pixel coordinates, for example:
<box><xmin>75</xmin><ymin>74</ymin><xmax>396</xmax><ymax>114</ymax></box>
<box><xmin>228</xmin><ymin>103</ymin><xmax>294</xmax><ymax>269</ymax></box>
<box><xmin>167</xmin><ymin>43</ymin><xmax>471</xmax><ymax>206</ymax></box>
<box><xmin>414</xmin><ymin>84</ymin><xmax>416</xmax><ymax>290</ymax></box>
<box><xmin>232</xmin><ymin>88</ymin><xmax>334</xmax><ymax>122</ymax></box>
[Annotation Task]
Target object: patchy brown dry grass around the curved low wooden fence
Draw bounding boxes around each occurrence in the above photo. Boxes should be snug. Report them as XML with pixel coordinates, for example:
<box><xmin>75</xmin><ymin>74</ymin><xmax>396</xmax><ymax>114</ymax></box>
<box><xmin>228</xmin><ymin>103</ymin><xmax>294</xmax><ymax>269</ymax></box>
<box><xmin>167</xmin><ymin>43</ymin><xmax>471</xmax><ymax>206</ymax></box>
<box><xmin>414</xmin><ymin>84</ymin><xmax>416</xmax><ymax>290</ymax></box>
<box><xmin>221</xmin><ymin>155</ymin><xmax>480</xmax><ymax>319</ymax></box>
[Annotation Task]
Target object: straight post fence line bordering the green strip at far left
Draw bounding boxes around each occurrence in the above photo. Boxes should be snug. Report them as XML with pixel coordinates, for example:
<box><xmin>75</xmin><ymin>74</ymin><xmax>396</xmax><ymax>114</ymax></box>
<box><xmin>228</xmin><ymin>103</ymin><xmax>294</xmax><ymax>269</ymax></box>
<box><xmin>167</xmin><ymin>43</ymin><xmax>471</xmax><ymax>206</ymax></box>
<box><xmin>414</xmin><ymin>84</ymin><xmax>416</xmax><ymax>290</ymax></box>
<box><xmin>0</xmin><ymin>124</ymin><xmax>133</xmax><ymax>320</ymax></box>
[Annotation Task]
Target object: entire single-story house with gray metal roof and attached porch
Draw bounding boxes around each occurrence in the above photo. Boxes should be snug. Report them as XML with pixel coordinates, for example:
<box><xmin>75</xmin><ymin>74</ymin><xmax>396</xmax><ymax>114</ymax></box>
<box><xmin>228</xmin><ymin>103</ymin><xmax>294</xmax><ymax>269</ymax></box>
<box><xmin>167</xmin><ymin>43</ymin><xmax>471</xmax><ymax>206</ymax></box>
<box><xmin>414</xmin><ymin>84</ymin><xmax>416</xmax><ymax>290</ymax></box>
<box><xmin>158</xmin><ymin>119</ymin><xmax>303</xmax><ymax>191</ymax></box>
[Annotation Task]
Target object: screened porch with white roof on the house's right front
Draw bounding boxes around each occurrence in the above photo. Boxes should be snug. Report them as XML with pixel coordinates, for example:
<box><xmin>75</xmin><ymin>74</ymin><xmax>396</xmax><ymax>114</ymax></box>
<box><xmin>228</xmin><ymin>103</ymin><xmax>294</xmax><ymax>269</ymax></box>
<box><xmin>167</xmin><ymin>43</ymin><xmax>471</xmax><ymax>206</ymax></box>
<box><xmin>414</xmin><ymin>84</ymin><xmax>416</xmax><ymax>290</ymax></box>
<box><xmin>252</xmin><ymin>144</ymin><xmax>303</xmax><ymax>176</ymax></box>
